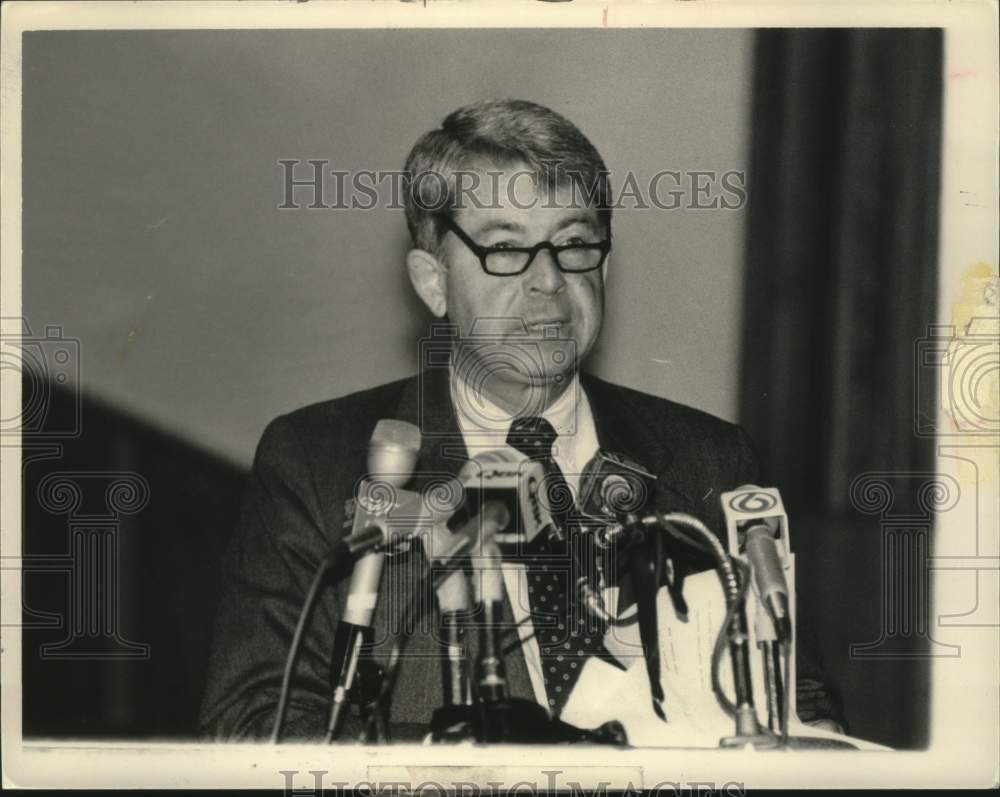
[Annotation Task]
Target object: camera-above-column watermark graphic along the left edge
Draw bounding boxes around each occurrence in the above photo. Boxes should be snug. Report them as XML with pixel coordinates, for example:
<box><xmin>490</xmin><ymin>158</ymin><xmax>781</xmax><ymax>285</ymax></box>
<box><xmin>0</xmin><ymin>317</ymin><xmax>150</xmax><ymax>660</ymax></box>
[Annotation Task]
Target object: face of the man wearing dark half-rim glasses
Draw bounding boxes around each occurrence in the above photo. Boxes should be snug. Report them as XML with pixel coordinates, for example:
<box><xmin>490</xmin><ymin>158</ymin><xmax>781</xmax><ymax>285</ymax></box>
<box><xmin>426</xmin><ymin>171</ymin><xmax>607</xmax><ymax>394</ymax></box>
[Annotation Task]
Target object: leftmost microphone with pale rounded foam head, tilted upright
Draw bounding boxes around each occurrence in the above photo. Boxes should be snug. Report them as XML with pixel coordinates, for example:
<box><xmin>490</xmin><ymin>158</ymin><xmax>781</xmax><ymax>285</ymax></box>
<box><xmin>327</xmin><ymin>420</ymin><xmax>421</xmax><ymax>740</ymax></box>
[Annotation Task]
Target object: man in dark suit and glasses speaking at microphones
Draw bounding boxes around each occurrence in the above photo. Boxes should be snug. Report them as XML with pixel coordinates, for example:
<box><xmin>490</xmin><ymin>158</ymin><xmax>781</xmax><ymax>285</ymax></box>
<box><xmin>202</xmin><ymin>100</ymin><xmax>837</xmax><ymax>739</ymax></box>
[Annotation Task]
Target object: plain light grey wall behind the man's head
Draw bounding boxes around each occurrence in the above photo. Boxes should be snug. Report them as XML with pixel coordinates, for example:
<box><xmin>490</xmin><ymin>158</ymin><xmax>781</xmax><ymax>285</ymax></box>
<box><xmin>23</xmin><ymin>30</ymin><xmax>752</xmax><ymax>465</ymax></box>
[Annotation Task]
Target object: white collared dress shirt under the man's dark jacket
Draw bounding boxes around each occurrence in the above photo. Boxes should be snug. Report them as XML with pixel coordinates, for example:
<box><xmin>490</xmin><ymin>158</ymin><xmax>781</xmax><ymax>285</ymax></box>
<box><xmin>451</xmin><ymin>370</ymin><xmax>617</xmax><ymax>709</ymax></box>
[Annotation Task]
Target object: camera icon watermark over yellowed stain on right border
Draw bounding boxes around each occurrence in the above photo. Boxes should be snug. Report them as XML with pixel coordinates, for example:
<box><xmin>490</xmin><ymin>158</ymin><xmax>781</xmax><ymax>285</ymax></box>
<box><xmin>913</xmin><ymin>315</ymin><xmax>1000</xmax><ymax>437</ymax></box>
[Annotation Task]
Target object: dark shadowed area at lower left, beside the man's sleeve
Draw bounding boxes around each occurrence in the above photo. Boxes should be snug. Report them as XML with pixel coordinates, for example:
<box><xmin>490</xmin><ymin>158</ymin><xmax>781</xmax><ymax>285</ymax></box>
<box><xmin>21</xmin><ymin>380</ymin><xmax>245</xmax><ymax>739</ymax></box>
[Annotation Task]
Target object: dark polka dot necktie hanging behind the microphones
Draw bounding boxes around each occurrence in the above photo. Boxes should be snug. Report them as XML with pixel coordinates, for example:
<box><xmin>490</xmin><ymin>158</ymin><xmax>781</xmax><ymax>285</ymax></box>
<box><xmin>507</xmin><ymin>417</ymin><xmax>603</xmax><ymax>716</ymax></box>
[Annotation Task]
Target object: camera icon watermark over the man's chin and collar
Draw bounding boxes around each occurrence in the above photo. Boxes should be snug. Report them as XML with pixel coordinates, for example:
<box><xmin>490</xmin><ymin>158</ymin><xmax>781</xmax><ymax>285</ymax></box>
<box><xmin>418</xmin><ymin>316</ymin><xmax>578</xmax><ymax>436</ymax></box>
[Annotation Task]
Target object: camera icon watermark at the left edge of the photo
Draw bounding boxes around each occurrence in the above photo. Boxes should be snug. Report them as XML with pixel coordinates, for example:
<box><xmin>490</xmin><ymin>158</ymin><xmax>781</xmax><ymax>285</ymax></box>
<box><xmin>0</xmin><ymin>318</ymin><xmax>81</xmax><ymax>441</ymax></box>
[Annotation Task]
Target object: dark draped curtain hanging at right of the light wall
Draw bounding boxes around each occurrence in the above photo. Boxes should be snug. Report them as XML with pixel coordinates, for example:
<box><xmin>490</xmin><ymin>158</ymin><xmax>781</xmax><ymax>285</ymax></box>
<box><xmin>740</xmin><ymin>29</ymin><xmax>943</xmax><ymax>748</ymax></box>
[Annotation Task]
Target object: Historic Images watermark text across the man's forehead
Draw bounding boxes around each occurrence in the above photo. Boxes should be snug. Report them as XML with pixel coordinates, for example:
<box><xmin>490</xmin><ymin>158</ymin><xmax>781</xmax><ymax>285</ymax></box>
<box><xmin>277</xmin><ymin>158</ymin><xmax>747</xmax><ymax>213</ymax></box>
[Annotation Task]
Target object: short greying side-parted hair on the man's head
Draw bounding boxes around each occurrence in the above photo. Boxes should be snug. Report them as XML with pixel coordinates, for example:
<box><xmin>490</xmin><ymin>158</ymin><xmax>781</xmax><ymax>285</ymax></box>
<box><xmin>404</xmin><ymin>99</ymin><xmax>611</xmax><ymax>252</ymax></box>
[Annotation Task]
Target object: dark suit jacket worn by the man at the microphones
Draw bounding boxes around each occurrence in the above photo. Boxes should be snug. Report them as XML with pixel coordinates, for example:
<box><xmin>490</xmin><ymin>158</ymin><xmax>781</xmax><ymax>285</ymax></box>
<box><xmin>201</xmin><ymin>369</ymin><xmax>839</xmax><ymax>739</ymax></box>
